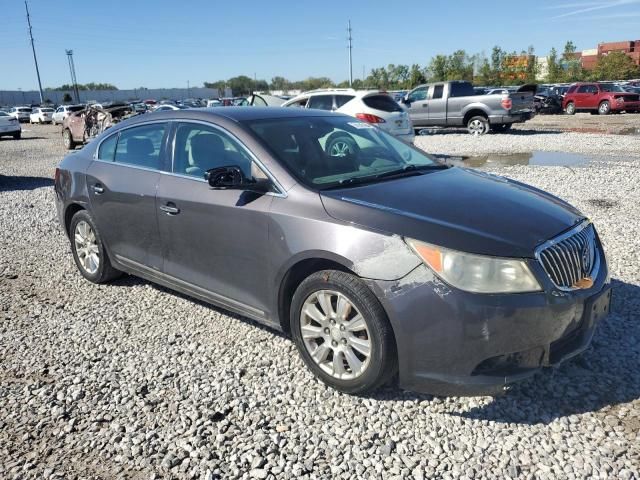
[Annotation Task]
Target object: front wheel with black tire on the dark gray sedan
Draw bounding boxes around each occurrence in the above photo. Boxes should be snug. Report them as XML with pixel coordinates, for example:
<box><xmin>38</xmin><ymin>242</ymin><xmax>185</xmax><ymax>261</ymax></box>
<box><xmin>291</xmin><ymin>270</ymin><xmax>397</xmax><ymax>394</ymax></box>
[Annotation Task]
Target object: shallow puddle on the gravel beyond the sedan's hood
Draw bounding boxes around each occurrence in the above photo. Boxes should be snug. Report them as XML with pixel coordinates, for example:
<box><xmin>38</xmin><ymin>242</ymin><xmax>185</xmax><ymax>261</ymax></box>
<box><xmin>436</xmin><ymin>152</ymin><xmax>591</xmax><ymax>168</ymax></box>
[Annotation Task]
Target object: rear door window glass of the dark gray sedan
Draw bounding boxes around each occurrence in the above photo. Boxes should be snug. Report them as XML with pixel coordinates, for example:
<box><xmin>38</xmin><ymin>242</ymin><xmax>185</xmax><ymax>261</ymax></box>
<box><xmin>115</xmin><ymin>123</ymin><xmax>167</xmax><ymax>170</ymax></box>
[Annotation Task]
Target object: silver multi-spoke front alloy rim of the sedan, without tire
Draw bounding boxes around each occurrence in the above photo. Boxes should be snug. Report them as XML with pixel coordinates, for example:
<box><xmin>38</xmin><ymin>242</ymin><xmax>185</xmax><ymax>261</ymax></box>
<box><xmin>300</xmin><ymin>290</ymin><xmax>371</xmax><ymax>380</ymax></box>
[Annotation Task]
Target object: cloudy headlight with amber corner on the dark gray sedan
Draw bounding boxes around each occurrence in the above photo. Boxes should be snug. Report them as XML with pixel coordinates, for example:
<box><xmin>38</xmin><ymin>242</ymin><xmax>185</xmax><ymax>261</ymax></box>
<box><xmin>406</xmin><ymin>238</ymin><xmax>542</xmax><ymax>293</ymax></box>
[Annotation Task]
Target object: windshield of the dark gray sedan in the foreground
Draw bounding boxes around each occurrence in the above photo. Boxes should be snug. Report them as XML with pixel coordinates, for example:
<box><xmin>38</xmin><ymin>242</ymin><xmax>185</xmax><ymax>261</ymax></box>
<box><xmin>245</xmin><ymin>115</ymin><xmax>442</xmax><ymax>190</ymax></box>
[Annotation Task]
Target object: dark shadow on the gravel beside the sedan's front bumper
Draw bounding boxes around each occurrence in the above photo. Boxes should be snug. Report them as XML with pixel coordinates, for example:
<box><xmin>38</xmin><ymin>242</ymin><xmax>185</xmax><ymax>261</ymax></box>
<box><xmin>451</xmin><ymin>280</ymin><xmax>640</xmax><ymax>425</ymax></box>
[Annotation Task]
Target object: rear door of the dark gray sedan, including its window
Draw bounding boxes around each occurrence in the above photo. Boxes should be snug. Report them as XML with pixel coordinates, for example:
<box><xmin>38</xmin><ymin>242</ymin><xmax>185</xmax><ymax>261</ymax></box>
<box><xmin>87</xmin><ymin>122</ymin><xmax>168</xmax><ymax>271</ymax></box>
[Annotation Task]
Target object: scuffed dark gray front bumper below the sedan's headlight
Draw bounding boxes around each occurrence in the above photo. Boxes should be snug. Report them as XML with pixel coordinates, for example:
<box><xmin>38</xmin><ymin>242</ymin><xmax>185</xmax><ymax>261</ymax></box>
<box><xmin>370</xmin><ymin>256</ymin><xmax>611</xmax><ymax>395</ymax></box>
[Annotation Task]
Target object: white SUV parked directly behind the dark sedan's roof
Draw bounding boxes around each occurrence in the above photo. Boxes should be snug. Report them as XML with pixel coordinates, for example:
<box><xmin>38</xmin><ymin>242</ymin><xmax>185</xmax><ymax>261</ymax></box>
<box><xmin>282</xmin><ymin>88</ymin><xmax>415</xmax><ymax>143</ymax></box>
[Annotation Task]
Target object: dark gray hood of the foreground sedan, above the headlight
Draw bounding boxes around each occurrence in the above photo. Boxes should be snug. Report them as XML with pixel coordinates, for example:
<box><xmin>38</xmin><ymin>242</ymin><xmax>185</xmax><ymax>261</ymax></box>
<box><xmin>320</xmin><ymin>168</ymin><xmax>584</xmax><ymax>258</ymax></box>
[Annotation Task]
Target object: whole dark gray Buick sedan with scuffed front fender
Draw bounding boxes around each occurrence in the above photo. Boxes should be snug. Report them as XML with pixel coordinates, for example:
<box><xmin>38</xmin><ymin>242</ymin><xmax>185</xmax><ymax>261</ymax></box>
<box><xmin>55</xmin><ymin>107</ymin><xmax>610</xmax><ymax>393</ymax></box>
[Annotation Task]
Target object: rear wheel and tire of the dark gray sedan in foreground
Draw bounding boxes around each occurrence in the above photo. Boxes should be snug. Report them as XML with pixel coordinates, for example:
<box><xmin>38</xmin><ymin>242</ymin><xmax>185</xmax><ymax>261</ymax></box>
<box><xmin>69</xmin><ymin>210</ymin><xmax>122</xmax><ymax>283</ymax></box>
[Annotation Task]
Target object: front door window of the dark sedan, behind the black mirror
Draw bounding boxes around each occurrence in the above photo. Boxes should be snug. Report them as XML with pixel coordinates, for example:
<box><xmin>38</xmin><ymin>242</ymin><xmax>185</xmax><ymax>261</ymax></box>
<box><xmin>173</xmin><ymin>122</ymin><xmax>255</xmax><ymax>178</ymax></box>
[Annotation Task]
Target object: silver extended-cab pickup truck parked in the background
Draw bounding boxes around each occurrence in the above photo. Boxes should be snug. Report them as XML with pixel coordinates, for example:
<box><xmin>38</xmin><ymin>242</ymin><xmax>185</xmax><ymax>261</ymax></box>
<box><xmin>402</xmin><ymin>81</ymin><xmax>536</xmax><ymax>135</ymax></box>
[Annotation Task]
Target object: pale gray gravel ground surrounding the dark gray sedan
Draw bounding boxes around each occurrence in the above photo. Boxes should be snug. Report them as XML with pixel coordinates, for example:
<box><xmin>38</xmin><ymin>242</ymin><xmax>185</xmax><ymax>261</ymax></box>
<box><xmin>0</xmin><ymin>122</ymin><xmax>640</xmax><ymax>479</ymax></box>
